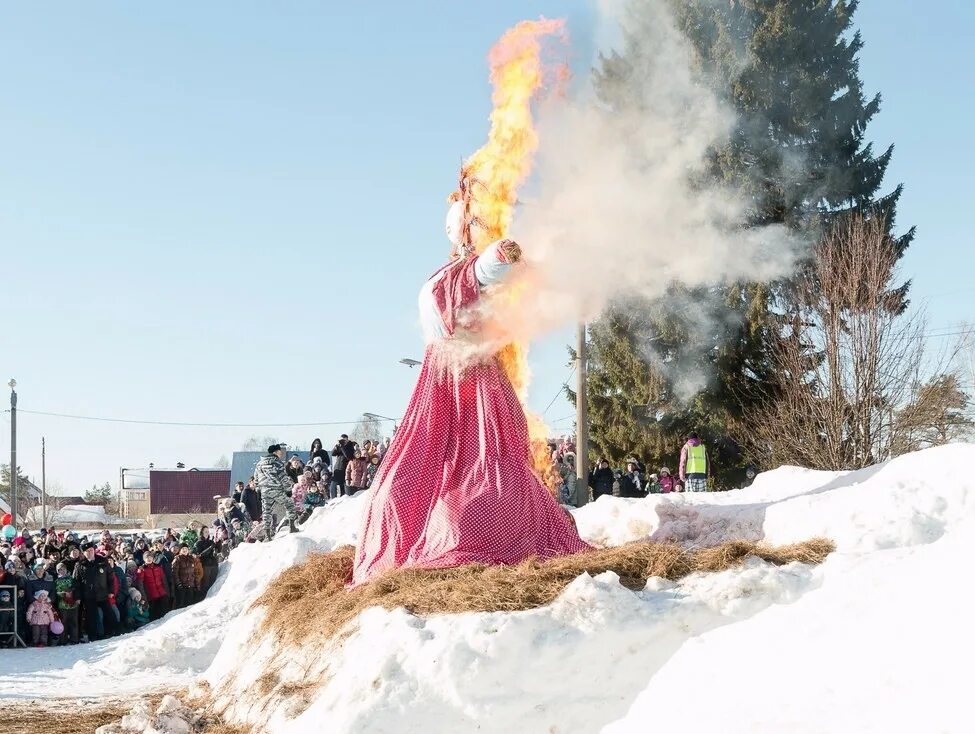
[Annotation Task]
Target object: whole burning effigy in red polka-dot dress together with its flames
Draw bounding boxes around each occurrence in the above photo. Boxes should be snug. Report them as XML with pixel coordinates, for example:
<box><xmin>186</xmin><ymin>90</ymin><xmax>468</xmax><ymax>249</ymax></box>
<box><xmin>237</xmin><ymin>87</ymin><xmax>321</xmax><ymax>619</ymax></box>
<box><xmin>353</xmin><ymin>20</ymin><xmax>589</xmax><ymax>584</ymax></box>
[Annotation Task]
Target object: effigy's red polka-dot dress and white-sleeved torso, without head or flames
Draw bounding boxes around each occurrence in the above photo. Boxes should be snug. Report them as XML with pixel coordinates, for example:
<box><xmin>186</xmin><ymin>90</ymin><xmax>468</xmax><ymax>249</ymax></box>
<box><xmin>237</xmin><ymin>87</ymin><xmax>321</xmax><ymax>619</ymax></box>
<box><xmin>353</xmin><ymin>221</ymin><xmax>589</xmax><ymax>584</ymax></box>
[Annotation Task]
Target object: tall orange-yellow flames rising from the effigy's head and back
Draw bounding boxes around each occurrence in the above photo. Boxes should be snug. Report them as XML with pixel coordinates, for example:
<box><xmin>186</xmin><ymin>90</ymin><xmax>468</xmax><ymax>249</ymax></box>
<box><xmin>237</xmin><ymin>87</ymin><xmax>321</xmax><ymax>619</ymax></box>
<box><xmin>452</xmin><ymin>19</ymin><xmax>566</xmax><ymax>500</ymax></box>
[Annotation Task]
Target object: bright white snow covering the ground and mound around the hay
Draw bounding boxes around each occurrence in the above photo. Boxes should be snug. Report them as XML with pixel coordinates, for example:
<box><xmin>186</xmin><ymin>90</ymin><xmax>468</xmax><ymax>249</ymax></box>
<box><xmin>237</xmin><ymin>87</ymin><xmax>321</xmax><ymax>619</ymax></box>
<box><xmin>0</xmin><ymin>445</ymin><xmax>975</xmax><ymax>734</ymax></box>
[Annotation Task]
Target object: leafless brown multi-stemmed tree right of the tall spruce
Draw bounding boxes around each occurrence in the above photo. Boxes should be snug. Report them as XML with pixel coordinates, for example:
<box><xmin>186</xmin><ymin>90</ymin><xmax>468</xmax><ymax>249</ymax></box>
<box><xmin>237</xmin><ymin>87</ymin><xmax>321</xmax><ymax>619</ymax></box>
<box><xmin>741</xmin><ymin>216</ymin><xmax>965</xmax><ymax>469</ymax></box>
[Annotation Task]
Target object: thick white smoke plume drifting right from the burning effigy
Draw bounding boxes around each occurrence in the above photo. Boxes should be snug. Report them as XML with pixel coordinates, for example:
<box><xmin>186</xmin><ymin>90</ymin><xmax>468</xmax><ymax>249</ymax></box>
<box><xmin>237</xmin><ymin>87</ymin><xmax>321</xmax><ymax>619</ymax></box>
<box><xmin>496</xmin><ymin>2</ymin><xmax>802</xmax><ymax>356</ymax></box>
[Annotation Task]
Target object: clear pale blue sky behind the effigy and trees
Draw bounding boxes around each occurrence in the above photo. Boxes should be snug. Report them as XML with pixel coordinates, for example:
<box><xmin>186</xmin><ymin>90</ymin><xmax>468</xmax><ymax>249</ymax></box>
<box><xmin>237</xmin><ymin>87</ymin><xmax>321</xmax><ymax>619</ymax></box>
<box><xmin>0</xmin><ymin>0</ymin><xmax>975</xmax><ymax>494</ymax></box>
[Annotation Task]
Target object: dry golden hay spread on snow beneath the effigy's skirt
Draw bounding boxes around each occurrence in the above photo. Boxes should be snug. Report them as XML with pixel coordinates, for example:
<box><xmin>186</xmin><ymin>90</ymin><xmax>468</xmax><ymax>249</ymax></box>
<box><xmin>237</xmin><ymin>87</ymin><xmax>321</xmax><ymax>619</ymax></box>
<box><xmin>255</xmin><ymin>538</ymin><xmax>835</xmax><ymax>645</ymax></box>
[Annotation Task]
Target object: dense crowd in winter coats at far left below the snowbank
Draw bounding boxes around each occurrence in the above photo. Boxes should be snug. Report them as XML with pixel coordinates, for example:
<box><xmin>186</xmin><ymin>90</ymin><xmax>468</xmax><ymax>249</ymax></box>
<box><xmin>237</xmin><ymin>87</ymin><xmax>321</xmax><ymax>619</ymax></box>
<box><xmin>0</xmin><ymin>522</ymin><xmax>222</xmax><ymax>647</ymax></box>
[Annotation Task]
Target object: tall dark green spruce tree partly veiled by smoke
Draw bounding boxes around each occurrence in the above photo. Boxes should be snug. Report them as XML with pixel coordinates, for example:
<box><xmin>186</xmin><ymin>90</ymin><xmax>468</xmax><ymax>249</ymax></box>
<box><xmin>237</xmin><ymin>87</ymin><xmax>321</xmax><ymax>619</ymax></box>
<box><xmin>589</xmin><ymin>0</ymin><xmax>914</xmax><ymax>485</ymax></box>
